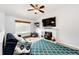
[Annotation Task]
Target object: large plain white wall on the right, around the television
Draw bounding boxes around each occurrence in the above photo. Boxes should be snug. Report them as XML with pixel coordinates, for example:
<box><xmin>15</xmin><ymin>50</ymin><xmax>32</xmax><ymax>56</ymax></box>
<box><xmin>39</xmin><ymin>5</ymin><xmax>79</xmax><ymax>48</ymax></box>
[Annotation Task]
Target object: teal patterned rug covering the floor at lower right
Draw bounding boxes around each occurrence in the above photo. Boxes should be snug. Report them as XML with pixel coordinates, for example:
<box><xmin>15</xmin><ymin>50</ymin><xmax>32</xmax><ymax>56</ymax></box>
<box><xmin>31</xmin><ymin>39</ymin><xmax>79</xmax><ymax>55</ymax></box>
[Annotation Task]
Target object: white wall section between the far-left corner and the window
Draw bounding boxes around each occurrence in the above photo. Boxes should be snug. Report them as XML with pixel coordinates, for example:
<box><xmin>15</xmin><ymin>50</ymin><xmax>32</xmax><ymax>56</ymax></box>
<box><xmin>5</xmin><ymin>16</ymin><xmax>15</xmax><ymax>34</ymax></box>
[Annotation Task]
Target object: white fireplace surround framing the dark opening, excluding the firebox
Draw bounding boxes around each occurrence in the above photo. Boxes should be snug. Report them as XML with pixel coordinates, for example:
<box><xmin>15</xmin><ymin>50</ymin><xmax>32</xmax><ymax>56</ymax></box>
<box><xmin>40</xmin><ymin>27</ymin><xmax>59</xmax><ymax>41</ymax></box>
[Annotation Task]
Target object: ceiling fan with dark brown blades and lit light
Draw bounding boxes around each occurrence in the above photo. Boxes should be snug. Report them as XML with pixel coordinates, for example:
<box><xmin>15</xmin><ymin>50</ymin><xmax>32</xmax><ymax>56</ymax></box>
<box><xmin>27</xmin><ymin>4</ymin><xmax>45</xmax><ymax>14</ymax></box>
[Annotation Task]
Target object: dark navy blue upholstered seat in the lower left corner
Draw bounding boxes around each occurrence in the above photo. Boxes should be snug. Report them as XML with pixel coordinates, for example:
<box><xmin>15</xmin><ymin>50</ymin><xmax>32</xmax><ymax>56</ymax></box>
<box><xmin>3</xmin><ymin>33</ymin><xmax>18</xmax><ymax>55</ymax></box>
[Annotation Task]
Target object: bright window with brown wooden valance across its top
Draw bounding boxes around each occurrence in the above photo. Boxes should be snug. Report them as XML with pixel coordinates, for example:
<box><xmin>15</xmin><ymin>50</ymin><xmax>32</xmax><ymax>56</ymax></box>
<box><xmin>15</xmin><ymin>20</ymin><xmax>31</xmax><ymax>33</ymax></box>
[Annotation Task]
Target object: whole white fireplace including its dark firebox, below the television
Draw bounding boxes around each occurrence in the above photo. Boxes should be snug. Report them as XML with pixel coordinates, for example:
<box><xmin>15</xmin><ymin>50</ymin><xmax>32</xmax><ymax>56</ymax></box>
<box><xmin>40</xmin><ymin>27</ymin><xmax>59</xmax><ymax>41</ymax></box>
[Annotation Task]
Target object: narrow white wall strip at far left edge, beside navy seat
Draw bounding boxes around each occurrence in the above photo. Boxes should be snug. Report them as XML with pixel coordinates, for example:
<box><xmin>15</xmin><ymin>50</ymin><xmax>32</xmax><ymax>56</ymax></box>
<box><xmin>0</xmin><ymin>12</ymin><xmax>5</xmax><ymax>55</ymax></box>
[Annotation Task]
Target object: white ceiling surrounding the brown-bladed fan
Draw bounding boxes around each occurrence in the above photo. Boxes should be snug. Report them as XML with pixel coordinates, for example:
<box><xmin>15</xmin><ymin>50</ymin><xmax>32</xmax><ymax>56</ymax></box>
<box><xmin>0</xmin><ymin>4</ymin><xmax>64</xmax><ymax>20</ymax></box>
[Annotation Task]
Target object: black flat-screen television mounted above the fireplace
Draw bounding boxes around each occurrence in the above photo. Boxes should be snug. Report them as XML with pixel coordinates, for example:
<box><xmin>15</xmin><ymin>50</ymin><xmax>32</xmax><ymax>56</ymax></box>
<box><xmin>42</xmin><ymin>17</ymin><xmax>56</xmax><ymax>27</ymax></box>
